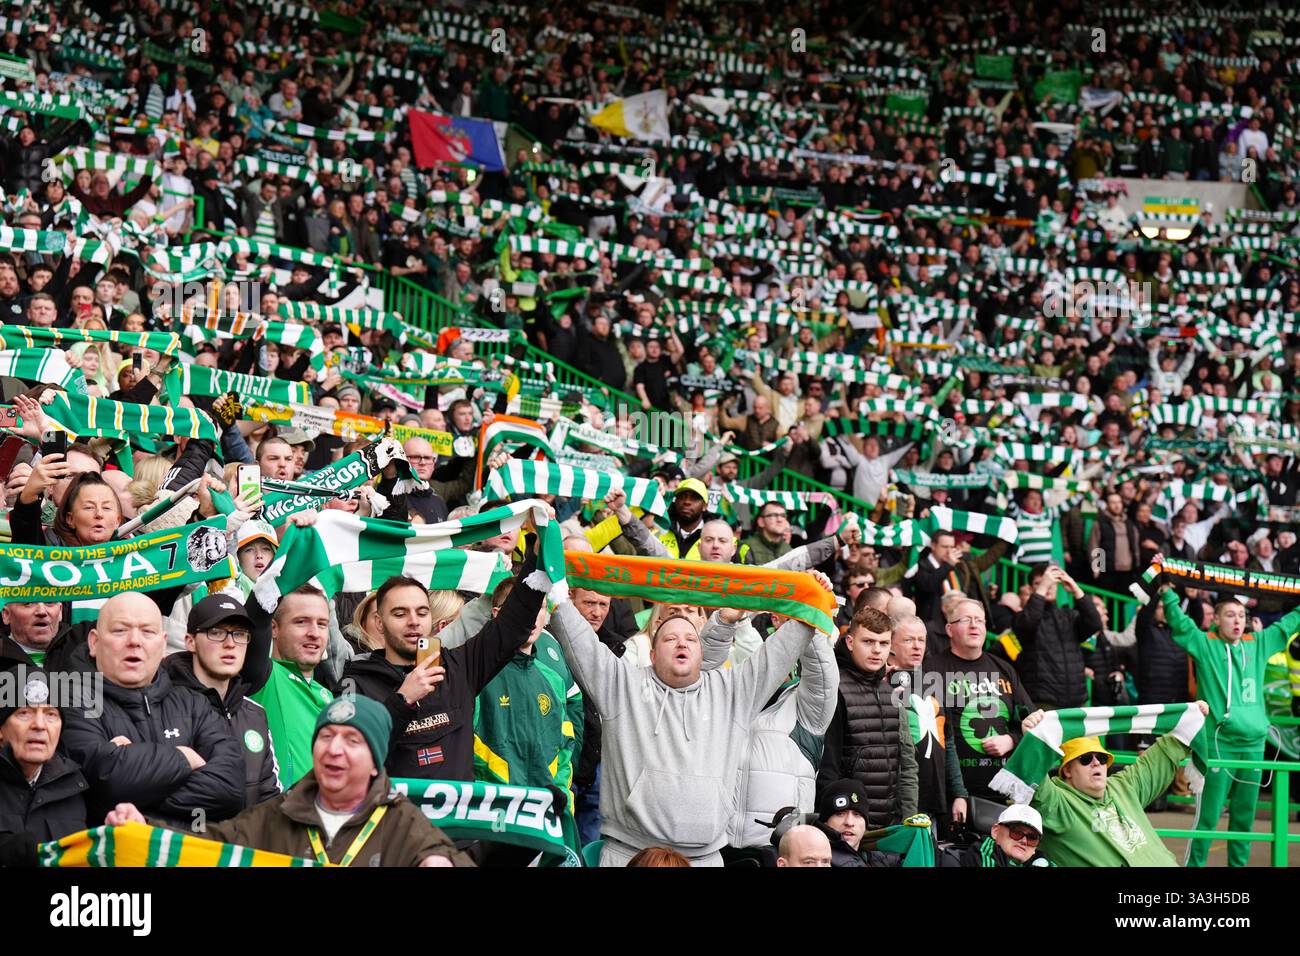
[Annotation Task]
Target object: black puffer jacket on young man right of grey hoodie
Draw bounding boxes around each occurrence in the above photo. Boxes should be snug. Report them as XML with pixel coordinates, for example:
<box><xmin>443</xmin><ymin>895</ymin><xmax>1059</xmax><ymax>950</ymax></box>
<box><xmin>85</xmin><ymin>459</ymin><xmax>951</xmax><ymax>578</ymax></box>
<box><xmin>816</xmin><ymin>641</ymin><xmax>918</xmax><ymax>829</ymax></box>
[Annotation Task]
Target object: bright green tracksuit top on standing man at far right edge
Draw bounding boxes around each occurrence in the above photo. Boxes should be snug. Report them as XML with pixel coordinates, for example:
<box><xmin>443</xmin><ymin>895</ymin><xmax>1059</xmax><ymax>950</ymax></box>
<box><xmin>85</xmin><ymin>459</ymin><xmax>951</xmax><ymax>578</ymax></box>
<box><xmin>1161</xmin><ymin>591</ymin><xmax>1300</xmax><ymax>756</ymax></box>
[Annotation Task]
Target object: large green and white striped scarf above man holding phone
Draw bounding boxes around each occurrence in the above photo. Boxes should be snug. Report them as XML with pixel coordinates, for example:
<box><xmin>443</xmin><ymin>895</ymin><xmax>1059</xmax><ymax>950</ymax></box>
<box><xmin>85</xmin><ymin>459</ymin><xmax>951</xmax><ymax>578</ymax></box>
<box><xmin>252</xmin><ymin>498</ymin><xmax>564</xmax><ymax>611</ymax></box>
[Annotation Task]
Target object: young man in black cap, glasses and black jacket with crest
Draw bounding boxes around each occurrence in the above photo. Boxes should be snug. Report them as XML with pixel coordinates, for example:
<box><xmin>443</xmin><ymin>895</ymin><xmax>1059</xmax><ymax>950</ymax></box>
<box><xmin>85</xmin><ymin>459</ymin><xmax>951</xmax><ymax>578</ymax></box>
<box><xmin>164</xmin><ymin>594</ymin><xmax>281</xmax><ymax>808</ymax></box>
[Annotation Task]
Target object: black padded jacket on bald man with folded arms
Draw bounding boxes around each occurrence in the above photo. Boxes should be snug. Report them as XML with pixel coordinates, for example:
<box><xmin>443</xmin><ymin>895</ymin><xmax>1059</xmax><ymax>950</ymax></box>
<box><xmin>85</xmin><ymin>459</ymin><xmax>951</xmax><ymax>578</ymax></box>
<box><xmin>64</xmin><ymin>667</ymin><xmax>244</xmax><ymax>827</ymax></box>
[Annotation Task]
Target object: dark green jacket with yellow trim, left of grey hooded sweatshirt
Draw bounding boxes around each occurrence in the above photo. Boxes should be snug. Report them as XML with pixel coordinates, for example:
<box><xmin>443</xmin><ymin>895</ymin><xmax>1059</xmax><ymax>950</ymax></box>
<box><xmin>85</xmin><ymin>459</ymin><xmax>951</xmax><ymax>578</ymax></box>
<box><xmin>475</xmin><ymin>653</ymin><xmax>576</xmax><ymax>809</ymax></box>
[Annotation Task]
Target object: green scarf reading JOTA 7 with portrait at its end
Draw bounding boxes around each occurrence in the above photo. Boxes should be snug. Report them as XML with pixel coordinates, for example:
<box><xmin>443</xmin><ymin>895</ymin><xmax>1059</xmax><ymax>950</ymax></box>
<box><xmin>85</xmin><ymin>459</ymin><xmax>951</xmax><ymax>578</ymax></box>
<box><xmin>0</xmin><ymin>518</ymin><xmax>239</xmax><ymax>622</ymax></box>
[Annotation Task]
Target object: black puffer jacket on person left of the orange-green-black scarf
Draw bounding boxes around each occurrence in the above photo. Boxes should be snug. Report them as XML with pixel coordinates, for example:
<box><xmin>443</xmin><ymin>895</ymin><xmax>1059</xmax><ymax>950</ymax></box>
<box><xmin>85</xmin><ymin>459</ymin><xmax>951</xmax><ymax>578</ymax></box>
<box><xmin>1011</xmin><ymin>593</ymin><xmax>1101</xmax><ymax>709</ymax></box>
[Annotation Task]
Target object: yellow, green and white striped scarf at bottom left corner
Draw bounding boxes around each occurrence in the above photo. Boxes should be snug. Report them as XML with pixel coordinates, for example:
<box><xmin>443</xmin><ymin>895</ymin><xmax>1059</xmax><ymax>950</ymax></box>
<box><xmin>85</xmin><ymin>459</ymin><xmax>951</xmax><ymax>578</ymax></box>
<box><xmin>36</xmin><ymin>823</ymin><xmax>319</xmax><ymax>868</ymax></box>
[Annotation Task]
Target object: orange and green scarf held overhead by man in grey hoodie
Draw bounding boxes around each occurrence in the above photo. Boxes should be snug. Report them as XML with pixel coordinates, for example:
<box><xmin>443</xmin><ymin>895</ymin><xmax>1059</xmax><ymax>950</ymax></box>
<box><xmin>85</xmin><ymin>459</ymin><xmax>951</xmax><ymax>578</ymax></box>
<box><xmin>564</xmin><ymin>551</ymin><xmax>837</xmax><ymax>635</ymax></box>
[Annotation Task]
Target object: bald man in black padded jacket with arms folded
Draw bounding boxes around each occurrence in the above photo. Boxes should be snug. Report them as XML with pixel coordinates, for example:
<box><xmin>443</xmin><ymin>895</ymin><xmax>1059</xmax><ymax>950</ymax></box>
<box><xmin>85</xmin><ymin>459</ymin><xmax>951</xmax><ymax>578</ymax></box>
<box><xmin>64</xmin><ymin>592</ymin><xmax>244</xmax><ymax>827</ymax></box>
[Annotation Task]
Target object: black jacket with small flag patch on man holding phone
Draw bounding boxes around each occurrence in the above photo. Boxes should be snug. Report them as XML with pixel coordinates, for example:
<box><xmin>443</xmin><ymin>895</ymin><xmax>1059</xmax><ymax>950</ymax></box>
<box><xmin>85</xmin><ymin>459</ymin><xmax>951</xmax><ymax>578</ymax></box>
<box><xmin>343</xmin><ymin>554</ymin><xmax>545</xmax><ymax>780</ymax></box>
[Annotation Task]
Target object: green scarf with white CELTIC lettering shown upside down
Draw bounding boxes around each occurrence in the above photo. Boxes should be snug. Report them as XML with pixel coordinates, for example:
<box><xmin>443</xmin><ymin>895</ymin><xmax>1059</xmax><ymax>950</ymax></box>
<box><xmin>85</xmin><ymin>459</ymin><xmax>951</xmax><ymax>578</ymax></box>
<box><xmin>393</xmin><ymin>777</ymin><xmax>582</xmax><ymax>866</ymax></box>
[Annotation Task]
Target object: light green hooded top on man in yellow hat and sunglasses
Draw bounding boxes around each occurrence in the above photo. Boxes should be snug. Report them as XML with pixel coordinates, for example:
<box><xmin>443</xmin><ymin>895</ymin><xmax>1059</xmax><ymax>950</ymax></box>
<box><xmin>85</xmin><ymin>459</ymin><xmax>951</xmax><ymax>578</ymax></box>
<box><xmin>1030</xmin><ymin>734</ymin><xmax>1190</xmax><ymax>866</ymax></box>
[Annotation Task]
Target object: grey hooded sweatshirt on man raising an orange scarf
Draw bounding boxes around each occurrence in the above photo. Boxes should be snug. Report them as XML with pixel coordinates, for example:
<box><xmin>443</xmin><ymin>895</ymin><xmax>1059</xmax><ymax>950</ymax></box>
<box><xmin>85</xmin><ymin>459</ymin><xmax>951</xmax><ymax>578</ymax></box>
<box><xmin>550</xmin><ymin>602</ymin><xmax>813</xmax><ymax>864</ymax></box>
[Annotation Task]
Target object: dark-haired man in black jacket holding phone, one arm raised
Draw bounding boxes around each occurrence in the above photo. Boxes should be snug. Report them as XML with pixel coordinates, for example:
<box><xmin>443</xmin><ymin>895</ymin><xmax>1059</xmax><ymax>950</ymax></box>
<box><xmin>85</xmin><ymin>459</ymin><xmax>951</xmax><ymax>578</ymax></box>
<box><xmin>343</xmin><ymin>535</ymin><xmax>551</xmax><ymax>780</ymax></box>
